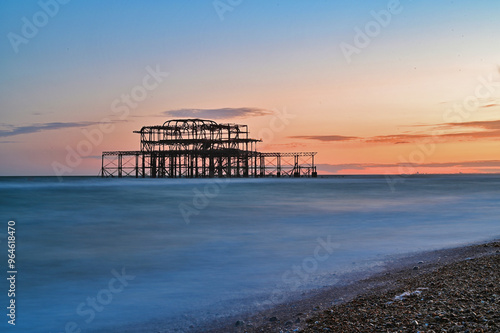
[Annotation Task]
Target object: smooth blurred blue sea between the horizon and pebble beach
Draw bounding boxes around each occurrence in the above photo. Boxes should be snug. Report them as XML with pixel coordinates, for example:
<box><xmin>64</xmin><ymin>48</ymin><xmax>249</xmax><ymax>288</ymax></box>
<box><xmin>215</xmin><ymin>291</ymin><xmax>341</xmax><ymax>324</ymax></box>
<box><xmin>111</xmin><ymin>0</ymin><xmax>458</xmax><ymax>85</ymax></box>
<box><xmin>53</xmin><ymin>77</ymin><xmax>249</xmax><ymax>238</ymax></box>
<box><xmin>0</xmin><ymin>175</ymin><xmax>500</xmax><ymax>333</ymax></box>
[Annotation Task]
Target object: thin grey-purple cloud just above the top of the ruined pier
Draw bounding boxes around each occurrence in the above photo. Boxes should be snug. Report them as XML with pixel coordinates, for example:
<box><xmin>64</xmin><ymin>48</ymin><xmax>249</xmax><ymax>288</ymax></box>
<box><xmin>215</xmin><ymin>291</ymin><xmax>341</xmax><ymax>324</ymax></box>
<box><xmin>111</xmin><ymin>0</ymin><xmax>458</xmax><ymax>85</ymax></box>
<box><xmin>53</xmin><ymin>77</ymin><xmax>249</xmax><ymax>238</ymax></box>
<box><xmin>162</xmin><ymin>107</ymin><xmax>273</xmax><ymax>119</ymax></box>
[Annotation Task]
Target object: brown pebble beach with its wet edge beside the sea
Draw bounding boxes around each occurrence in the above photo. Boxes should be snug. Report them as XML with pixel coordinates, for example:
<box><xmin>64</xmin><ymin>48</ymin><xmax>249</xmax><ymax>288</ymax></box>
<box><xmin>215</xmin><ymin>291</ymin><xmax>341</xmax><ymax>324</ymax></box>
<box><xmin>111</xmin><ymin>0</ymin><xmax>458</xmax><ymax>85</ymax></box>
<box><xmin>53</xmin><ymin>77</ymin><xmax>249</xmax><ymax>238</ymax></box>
<box><xmin>203</xmin><ymin>240</ymin><xmax>500</xmax><ymax>333</ymax></box>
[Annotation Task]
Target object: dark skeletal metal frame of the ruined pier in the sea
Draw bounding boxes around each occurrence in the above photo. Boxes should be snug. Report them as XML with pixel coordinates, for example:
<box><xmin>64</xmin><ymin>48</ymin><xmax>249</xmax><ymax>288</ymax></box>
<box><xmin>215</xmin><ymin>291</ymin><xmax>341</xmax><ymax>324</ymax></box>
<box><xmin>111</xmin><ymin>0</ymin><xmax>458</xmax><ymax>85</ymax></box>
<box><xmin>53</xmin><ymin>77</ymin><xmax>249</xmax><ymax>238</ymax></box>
<box><xmin>100</xmin><ymin>119</ymin><xmax>317</xmax><ymax>178</ymax></box>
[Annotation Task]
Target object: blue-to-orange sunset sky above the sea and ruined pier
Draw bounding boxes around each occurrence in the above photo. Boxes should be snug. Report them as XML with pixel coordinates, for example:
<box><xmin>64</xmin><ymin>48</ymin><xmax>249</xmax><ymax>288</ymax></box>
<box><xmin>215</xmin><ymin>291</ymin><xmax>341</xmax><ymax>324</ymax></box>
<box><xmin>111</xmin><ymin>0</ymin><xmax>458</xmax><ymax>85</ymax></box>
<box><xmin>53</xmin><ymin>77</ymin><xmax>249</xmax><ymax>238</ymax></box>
<box><xmin>0</xmin><ymin>0</ymin><xmax>500</xmax><ymax>176</ymax></box>
